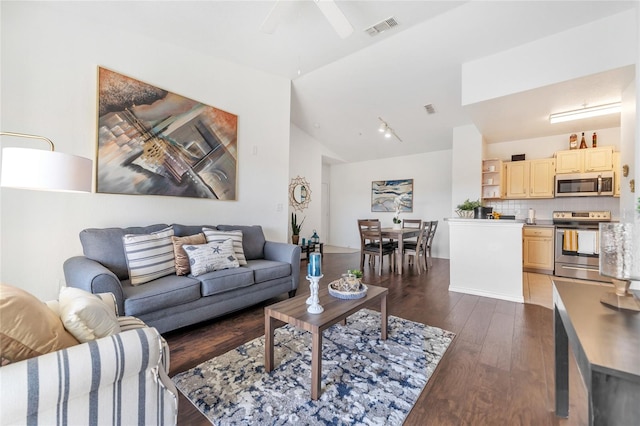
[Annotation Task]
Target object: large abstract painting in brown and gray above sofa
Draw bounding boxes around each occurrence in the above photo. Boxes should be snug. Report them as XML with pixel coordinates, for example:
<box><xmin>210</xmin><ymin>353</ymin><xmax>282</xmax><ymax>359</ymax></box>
<box><xmin>96</xmin><ymin>67</ymin><xmax>238</xmax><ymax>200</ymax></box>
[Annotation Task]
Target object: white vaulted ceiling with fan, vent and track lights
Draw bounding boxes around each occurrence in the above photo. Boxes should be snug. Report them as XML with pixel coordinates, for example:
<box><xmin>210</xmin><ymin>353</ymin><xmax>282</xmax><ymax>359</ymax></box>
<box><xmin>51</xmin><ymin>0</ymin><xmax>637</xmax><ymax>161</ymax></box>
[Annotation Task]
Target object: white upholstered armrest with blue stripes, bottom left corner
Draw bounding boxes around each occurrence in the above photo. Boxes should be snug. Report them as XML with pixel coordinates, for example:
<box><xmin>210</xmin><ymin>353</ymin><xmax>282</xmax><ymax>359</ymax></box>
<box><xmin>0</xmin><ymin>328</ymin><xmax>178</xmax><ymax>425</ymax></box>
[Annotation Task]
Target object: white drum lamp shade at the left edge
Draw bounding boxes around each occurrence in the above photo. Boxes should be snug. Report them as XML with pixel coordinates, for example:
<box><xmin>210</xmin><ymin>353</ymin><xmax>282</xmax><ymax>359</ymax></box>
<box><xmin>0</xmin><ymin>148</ymin><xmax>93</xmax><ymax>192</ymax></box>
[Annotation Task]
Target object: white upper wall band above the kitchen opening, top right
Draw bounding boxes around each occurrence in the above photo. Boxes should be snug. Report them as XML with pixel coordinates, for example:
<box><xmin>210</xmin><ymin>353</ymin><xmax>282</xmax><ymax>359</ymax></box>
<box><xmin>462</xmin><ymin>9</ymin><xmax>638</xmax><ymax>105</ymax></box>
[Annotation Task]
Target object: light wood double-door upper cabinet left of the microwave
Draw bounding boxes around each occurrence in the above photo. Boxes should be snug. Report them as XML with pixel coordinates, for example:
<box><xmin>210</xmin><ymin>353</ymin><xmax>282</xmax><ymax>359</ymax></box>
<box><xmin>505</xmin><ymin>158</ymin><xmax>556</xmax><ymax>199</ymax></box>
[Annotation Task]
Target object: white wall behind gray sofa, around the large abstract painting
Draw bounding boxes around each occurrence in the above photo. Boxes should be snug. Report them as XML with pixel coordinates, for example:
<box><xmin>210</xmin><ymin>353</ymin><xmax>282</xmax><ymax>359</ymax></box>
<box><xmin>0</xmin><ymin>2</ymin><xmax>291</xmax><ymax>300</ymax></box>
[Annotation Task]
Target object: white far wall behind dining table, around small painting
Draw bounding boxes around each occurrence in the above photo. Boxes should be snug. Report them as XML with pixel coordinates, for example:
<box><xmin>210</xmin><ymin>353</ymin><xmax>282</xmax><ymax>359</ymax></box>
<box><xmin>329</xmin><ymin>150</ymin><xmax>452</xmax><ymax>258</ymax></box>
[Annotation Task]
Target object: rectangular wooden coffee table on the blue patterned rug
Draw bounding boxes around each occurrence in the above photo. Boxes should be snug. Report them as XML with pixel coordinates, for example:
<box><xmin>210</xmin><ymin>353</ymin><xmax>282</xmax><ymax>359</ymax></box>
<box><xmin>264</xmin><ymin>284</ymin><xmax>389</xmax><ymax>400</ymax></box>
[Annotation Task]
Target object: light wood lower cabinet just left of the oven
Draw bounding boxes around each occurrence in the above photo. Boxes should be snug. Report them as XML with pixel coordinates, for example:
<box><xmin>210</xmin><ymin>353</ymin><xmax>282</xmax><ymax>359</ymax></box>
<box><xmin>522</xmin><ymin>226</ymin><xmax>554</xmax><ymax>274</ymax></box>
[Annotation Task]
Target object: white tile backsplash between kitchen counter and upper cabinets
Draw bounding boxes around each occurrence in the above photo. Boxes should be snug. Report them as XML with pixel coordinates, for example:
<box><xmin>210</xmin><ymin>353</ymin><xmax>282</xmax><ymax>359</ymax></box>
<box><xmin>484</xmin><ymin>197</ymin><xmax>620</xmax><ymax>220</ymax></box>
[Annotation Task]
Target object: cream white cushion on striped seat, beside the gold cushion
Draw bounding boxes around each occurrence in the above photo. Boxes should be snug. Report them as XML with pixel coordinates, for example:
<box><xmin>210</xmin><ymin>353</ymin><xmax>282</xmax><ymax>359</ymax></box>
<box><xmin>58</xmin><ymin>287</ymin><xmax>120</xmax><ymax>343</ymax></box>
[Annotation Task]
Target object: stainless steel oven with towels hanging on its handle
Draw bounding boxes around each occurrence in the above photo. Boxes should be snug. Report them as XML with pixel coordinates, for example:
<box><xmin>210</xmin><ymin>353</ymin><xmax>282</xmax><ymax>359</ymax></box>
<box><xmin>553</xmin><ymin>211</ymin><xmax>611</xmax><ymax>281</ymax></box>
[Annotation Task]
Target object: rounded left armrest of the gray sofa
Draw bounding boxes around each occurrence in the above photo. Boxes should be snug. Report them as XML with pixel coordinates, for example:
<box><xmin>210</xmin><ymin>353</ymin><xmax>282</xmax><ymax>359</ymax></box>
<box><xmin>62</xmin><ymin>256</ymin><xmax>124</xmax><ymax>315</ymax></box>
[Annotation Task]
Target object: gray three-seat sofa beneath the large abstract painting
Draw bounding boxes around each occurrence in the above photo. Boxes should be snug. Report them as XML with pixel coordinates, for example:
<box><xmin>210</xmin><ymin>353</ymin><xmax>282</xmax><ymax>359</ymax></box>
<box><xmin>64</xmin><ymin>224</ymin><xmax>300</xmax><ymax>333</ymax></box>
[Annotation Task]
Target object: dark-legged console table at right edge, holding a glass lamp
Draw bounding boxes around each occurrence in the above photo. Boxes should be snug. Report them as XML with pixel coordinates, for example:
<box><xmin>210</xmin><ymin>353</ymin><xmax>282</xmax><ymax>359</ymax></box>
<box><xmin>553</xmin><ymin>280</ymin><xmax>640</xmax><ymax>425</ymax></box>
